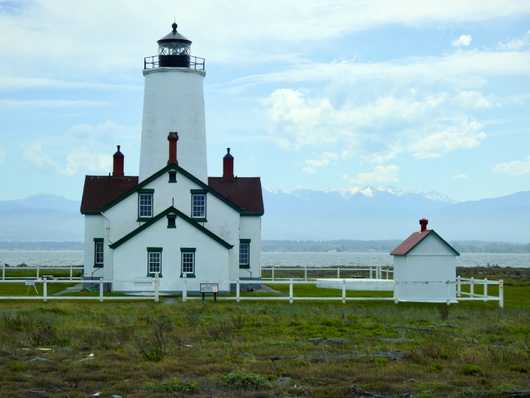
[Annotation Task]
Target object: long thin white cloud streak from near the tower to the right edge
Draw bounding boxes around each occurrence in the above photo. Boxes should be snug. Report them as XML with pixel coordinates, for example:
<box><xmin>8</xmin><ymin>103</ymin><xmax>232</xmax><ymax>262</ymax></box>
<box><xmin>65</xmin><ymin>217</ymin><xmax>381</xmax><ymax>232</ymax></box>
<box><xmin>229</xmin><ymin>50</ymin><xmax>530</xmax><ymax>89</ymax></box>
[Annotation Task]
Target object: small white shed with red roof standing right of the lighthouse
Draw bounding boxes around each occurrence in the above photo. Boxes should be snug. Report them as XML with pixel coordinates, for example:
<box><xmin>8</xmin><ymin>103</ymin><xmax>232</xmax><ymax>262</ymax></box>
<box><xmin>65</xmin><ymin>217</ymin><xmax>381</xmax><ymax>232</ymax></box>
<box><xmin>390</xmin><ymin>219</ymin><xmax>460</xmax><ymax>303</ymax></box>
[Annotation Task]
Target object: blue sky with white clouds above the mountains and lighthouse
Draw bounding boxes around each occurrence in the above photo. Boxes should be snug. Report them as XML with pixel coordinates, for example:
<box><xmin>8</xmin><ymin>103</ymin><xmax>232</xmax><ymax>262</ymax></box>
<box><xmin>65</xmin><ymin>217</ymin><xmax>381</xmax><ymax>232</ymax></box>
<box><xmin>0</xmin><ymin>0</ymin><xmax>530</xmax><ymax>201</ymax></box>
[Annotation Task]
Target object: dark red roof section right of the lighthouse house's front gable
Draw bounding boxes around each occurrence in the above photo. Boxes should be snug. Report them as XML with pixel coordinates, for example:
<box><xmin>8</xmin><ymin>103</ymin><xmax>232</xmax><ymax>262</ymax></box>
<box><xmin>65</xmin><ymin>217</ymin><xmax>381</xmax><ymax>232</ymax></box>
<box><xmin>208</xmin><ymin>177</ymin><xmax>264</xmax><ymax>215</ymax></box>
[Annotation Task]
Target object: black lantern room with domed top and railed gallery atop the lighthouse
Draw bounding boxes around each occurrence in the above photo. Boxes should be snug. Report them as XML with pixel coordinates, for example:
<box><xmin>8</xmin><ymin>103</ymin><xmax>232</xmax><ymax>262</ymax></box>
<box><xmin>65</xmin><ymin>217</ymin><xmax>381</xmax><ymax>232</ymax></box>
<box><xmin>144</xmin><ymin>22</ymin><xmax>205</xmax><ymax>72</ymax></box>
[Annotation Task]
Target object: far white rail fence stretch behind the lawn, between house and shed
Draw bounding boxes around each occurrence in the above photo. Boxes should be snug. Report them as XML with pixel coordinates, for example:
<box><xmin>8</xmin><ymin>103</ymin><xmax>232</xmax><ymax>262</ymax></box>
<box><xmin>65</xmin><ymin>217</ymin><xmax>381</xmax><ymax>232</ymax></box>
<box><xmin>261</xmin><ymin>265</ymin><xmax>394</xmax><ymax>281</ymax></box>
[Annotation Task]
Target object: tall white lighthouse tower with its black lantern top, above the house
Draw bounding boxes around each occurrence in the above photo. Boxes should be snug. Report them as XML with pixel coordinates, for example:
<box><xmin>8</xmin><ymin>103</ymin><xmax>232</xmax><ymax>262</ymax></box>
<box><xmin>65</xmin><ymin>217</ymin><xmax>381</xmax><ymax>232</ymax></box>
<box><xmin>139</xmin><ymin>23</ymin><xmax>208</xmax><ymax>183</ymax></box>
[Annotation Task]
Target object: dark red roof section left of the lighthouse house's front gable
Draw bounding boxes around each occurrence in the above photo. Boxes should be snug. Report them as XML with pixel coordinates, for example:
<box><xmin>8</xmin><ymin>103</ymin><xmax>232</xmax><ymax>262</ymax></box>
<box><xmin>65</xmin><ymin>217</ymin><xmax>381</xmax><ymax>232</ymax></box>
<box><xmin>81</xmin><ymin>176</ymin><xmax>138</xmax><ymax>214</ymax></box>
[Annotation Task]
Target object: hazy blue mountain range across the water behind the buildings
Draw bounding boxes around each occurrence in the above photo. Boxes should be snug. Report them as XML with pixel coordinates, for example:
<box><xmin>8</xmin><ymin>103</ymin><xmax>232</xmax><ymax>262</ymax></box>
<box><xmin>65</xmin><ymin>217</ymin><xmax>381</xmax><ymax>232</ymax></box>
<box><xmin>0</xmin><ymin>188</ymin><xmax>530</xmax><ymax>243</ymax></box>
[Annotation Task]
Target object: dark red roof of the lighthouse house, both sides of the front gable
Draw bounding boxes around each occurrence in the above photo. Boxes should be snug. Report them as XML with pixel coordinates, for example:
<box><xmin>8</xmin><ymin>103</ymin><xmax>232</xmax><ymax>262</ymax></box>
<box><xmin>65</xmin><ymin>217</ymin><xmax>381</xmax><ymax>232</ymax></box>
<box><xmin>81</xmin><ymin>172</ymin><xmax>263</xmax><ymax>215</ymax></box>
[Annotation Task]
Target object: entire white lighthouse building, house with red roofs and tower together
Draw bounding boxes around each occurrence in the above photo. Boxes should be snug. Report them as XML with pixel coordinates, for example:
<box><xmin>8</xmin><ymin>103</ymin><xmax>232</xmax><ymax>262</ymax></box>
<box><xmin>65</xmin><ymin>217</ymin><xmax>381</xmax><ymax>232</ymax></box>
<box><xmin>81</xmin><ymin>24</ymin><xmax>264</xmax><ymax>292</ymax></box>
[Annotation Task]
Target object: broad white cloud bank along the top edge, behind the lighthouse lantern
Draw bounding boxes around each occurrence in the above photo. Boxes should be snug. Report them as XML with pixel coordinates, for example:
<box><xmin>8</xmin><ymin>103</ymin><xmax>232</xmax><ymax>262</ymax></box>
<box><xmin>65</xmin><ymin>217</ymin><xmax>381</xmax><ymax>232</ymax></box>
<box><xmin>0</xmin><ymin>0</ymin><xmax>530</xmax><ymax>75</ymax></box>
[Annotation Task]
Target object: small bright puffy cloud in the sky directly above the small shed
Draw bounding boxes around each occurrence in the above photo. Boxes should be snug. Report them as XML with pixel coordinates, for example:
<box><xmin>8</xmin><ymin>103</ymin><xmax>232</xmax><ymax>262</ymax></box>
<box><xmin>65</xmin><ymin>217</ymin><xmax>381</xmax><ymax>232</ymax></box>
<box><xmin>411</xmin><ymin>121</ymin><xmax>486</xmax><ymax>159</ymax></box>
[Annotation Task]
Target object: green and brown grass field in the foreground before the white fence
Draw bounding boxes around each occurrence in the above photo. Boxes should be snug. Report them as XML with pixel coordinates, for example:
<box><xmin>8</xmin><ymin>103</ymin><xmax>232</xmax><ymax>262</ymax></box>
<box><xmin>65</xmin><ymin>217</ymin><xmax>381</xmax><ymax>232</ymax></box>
<box><xmin>0</xmin><ymin>271</ymin><xmax>530</xmax><ymax>398</ymax></box>
